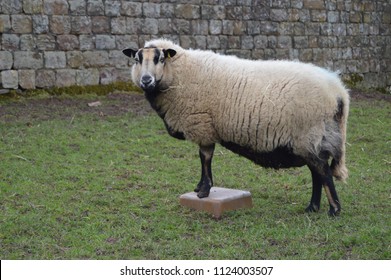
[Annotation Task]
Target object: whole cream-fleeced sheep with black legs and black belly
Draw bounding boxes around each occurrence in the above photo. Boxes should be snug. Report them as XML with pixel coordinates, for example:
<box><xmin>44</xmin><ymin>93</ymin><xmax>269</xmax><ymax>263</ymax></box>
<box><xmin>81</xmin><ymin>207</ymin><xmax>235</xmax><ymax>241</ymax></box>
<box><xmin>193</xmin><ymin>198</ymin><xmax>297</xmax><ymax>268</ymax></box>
<box><xmin>123</xmin><ymin>39</ymin><xmax>349</xmax><ymax>216</ymax></box>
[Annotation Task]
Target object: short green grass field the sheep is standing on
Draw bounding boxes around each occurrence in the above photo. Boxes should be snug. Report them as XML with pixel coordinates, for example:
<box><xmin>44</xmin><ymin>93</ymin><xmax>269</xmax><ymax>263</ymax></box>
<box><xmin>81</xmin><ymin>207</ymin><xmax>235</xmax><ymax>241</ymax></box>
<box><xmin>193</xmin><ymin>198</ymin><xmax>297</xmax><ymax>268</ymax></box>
<box><xmin>0</xmin><ymin>93</ymin><xmax>391</xmax><ymax>259</ymax></box>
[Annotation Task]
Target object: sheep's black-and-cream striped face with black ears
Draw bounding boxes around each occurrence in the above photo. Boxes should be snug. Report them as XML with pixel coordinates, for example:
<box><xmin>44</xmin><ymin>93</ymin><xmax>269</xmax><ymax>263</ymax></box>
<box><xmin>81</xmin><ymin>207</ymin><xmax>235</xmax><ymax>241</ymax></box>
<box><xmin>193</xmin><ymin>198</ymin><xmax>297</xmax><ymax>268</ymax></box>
<box><xmin>123</xmin><ymin>48</ymin><xmax>176</xmax><ymax>92</ymax></box>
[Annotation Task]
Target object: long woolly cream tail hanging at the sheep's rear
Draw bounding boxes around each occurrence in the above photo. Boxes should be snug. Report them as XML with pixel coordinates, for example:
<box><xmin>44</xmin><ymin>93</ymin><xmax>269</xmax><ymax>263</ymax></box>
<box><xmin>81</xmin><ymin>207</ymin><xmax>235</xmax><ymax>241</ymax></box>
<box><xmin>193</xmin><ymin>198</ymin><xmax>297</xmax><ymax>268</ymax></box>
<box><xmin>331</xmin><ymin>95</ymin><xmax>349</xmax><ymax>182</ymax></box>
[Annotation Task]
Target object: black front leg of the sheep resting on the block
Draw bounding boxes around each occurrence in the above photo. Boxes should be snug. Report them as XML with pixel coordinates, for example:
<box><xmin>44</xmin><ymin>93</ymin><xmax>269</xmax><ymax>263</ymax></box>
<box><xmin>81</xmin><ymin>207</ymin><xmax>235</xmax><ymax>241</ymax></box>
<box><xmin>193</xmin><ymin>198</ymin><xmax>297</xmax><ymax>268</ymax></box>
<box><xmin>194</xmin><ymin>144</ymin><xmax>215</xmax><ymax>198</ymax></box>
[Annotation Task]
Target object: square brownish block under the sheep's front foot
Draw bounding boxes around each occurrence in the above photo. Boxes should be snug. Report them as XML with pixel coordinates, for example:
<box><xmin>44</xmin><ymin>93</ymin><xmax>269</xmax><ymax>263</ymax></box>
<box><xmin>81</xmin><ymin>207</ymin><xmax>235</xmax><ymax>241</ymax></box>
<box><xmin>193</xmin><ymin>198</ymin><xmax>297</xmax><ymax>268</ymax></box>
<box><xmin>179</xmin><ymin>187</ymin><xmax>252</xmax><ymax>219</ymax></box>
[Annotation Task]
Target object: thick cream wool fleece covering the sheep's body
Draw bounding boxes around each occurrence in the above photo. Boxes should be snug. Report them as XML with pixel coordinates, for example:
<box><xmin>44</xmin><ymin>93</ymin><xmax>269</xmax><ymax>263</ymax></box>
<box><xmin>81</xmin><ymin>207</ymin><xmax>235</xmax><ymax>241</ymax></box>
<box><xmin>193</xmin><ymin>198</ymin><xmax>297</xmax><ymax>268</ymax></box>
<box><xmin>136</xmin><ymin>39</ymin><xmax>349</xmax><ymax>180</ymax></box>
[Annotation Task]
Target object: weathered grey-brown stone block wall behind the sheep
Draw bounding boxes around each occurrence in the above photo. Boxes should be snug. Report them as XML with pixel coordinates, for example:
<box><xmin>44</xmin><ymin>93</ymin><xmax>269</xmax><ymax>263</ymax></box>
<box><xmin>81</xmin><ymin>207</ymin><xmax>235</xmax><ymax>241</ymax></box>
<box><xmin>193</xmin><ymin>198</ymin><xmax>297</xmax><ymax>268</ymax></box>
<box><xmin>0</xmin><ymin>0</ymin><xmax>391</xmax><ymax>92</ymax></box>
